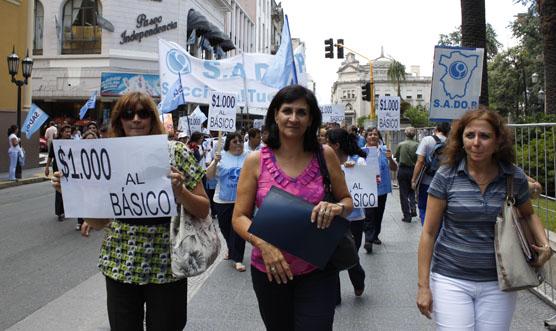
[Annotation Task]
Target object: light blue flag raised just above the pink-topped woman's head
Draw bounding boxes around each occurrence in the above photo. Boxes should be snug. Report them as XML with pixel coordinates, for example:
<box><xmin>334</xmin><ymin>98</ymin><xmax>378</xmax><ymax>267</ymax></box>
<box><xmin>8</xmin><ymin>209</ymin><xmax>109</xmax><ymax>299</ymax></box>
<box><xmin>262</xmin><ymin>15</ymin><xmax>297</xmax><ymax>89</ymax></box>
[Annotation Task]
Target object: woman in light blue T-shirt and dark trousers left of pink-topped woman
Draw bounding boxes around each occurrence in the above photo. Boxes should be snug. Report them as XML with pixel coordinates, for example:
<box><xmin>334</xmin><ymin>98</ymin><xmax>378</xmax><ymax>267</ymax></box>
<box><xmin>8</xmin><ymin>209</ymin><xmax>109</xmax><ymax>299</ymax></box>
<box><xmin>207</xmin><ymin>132</ymin><xmax>249</xmax><ymax>272</ymax></box>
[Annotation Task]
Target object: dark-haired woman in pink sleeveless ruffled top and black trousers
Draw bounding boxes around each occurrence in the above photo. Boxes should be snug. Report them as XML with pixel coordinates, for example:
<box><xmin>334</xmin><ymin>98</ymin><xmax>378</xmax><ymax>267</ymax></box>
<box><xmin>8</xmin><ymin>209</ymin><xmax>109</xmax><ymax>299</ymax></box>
<box><xmin>232</xmin><ymin>85</ymin><xmax>353</xmax><ymax>330</ymax></box>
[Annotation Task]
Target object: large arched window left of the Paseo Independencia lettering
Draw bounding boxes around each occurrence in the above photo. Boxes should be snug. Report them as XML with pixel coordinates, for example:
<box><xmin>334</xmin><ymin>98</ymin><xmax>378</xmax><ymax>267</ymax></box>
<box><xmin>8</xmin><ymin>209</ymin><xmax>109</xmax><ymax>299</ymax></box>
<box><xmin>62</xmin><ymin>0</ymin><xmax>102</xmax><ymax>54</ymax></box>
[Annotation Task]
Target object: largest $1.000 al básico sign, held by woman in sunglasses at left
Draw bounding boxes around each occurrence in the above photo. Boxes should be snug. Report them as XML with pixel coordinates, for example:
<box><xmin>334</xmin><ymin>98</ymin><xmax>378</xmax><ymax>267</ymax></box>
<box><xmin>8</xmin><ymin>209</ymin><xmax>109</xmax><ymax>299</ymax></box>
<box><xmin>53</xmin><ymin>135</ymin><xmax>177</xmax><ymax>219</ymax></box>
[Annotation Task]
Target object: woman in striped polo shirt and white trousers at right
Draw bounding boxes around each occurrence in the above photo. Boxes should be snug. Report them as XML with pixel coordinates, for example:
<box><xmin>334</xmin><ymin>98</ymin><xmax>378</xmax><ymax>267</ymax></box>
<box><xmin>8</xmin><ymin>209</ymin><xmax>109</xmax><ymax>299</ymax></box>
<box><xmin>417</xmin><ymin>108</ymin><xmax>552</xmax><ymax>330</ymax></box>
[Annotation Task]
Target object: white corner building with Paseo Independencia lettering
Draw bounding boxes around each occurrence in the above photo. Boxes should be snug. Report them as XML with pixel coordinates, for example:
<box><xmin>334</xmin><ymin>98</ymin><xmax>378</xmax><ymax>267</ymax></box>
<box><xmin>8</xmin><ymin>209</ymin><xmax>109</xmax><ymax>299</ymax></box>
<box><xmin>33</xmin><ymin>0</ymin><xmax>235</xmax><ymax>127</ymax></box>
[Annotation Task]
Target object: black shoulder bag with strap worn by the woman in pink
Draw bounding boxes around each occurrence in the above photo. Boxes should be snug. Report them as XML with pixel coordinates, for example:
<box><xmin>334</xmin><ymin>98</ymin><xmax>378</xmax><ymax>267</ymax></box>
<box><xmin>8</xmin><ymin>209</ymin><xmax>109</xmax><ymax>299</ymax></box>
<box><xmin>317</xmin><ymin>146</ymin><xmax>359</xmax><ymax>270</ymax></box>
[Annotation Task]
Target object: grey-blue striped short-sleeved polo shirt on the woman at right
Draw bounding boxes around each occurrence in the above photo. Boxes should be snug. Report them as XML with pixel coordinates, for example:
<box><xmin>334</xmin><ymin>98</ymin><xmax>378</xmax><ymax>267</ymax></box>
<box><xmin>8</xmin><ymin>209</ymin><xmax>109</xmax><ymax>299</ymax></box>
<box><xmin>428</xmin><ymin>158</ymin><xmax>529</xmax><ymax>282</ymax></box>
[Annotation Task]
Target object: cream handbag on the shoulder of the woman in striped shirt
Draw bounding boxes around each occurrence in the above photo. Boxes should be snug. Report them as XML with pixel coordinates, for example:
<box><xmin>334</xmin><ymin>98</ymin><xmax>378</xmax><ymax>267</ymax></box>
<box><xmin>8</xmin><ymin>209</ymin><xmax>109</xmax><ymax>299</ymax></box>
<box><xmin>494</xmin><ymin>176</ymin><xmax>543</xmax><ymax>292</ymax></box>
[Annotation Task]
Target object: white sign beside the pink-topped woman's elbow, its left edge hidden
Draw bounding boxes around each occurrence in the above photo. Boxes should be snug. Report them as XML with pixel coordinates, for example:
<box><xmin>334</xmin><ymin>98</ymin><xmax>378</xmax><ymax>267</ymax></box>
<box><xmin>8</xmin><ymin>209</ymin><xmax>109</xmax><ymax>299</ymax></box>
<box><xmin>344</xmin><ymin>165</ymin><xmax>378</xmax><ymax>208</ymax></box>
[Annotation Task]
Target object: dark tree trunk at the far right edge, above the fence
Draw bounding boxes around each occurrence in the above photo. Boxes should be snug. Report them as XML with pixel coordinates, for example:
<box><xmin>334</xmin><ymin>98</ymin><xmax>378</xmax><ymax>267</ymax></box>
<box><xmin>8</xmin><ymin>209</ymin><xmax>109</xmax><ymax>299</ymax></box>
<box><xmin>540</xmin><ymin>0</ymin><xmax>556</xmax><ymax>114</ymax></box>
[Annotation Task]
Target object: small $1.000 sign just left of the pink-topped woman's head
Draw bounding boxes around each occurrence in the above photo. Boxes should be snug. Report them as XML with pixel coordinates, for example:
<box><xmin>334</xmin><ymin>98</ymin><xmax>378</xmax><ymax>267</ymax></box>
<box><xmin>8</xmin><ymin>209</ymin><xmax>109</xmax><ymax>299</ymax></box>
<box><xmin>207</xmin><ymin>92</ymin><xmax>237</xmax><ymax>132</ymax></box>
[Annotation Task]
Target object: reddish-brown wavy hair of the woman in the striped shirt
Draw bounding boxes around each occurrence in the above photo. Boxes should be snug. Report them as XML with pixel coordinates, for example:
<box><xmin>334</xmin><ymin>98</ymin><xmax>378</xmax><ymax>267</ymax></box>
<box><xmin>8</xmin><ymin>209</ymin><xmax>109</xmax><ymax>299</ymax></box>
<box><xmin>442</xmin><ymin>106</ymin><xmax>515</xmax><ymax>167</ymax></box>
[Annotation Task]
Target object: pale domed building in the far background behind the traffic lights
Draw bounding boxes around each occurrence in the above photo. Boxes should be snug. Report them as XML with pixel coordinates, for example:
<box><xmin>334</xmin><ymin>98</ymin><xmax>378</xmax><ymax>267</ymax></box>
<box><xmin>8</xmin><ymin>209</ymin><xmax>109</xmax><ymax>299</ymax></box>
<box><xmin>331</xmin><ymin>53</ymin><xmax>432</xmax><ymax>125</ymax></box>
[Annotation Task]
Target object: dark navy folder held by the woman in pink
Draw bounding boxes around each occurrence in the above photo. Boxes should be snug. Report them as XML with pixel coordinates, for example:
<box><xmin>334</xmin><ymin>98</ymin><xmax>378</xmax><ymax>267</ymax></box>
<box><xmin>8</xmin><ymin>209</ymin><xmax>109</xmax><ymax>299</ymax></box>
<box><xmin>248</xmin><ymin>186</ymin><xmax>349</xmax><ymax>269</ymax></box>
